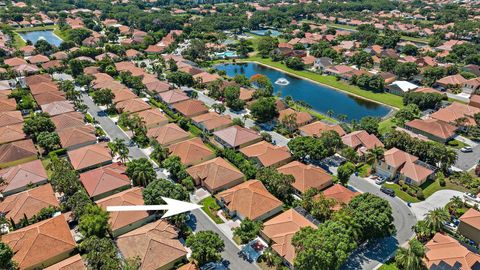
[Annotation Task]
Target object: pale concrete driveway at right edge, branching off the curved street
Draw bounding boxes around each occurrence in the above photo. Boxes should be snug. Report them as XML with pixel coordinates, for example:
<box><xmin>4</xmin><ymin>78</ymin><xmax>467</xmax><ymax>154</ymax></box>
<box><xmin>412</xmin><ymin>190</ymin><xmax>463</xmax><ymax>220</ymax></box>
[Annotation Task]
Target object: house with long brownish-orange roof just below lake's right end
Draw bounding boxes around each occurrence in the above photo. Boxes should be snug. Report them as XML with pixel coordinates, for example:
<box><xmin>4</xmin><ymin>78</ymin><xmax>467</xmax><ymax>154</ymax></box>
<box><xmin>405</xmin><ymin>118</ymin><xmax>457</xmax><ymax>143</ymax></box>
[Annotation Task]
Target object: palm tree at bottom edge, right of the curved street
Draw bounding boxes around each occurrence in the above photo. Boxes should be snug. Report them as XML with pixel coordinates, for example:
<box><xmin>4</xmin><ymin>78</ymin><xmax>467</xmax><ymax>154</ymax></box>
<box><xmin>395</xmin><ymin>239</ymin><xmax>425</xmax><ymax>270</ymax></box>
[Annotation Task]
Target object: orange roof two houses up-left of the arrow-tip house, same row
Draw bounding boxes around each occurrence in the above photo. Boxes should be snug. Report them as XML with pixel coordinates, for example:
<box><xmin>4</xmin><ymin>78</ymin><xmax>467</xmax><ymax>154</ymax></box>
<box><xmin>168</xmin><ymin>137</ymin><xmax>215</xmax><ymax>165</ymax></box>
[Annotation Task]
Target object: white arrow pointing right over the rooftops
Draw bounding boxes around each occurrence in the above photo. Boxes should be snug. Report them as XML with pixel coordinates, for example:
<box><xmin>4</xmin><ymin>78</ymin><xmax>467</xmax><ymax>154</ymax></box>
<box><xmin>107</xmin><ymin>197</ymin><xmax>202</xmax><ymax>218</ymax></box>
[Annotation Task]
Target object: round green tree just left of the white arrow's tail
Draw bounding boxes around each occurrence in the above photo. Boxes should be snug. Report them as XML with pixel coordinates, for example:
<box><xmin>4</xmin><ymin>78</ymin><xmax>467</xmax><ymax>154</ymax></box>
<box><xmin>78</xmin><ymin>204</ymin><xmax>110</xmax><ymax>238</ymax></box>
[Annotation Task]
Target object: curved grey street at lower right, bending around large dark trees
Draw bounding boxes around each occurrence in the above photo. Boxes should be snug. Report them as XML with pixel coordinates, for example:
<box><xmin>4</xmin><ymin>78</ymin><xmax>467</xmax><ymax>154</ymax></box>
<box><xmin>342</xmin><ymin>175</ymin><xmax>417</xmax><ymax>270</ymax></box>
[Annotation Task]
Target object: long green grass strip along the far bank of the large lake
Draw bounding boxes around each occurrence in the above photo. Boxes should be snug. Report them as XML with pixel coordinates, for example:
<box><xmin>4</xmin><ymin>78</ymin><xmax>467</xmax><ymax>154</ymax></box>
<box><xmin>245</xmin><ymin>56</ymin><xmax>403</xmax><ymax>108</ymax></box>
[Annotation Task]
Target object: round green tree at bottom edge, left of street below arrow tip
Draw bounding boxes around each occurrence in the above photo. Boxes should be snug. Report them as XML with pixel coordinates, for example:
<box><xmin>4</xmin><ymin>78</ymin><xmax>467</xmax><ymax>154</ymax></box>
<box><xmin>186</xmin><ymin>231</ymin><xmax>225</xmax><ymax>266</ymax></box>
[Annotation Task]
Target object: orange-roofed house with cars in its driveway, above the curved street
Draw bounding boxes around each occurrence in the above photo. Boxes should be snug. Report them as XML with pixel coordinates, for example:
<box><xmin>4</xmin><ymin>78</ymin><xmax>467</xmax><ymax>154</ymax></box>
<box><xmin>374</xmin><ymin>148</ymin><xmax>435</xmax><ymax>186</ymax></box>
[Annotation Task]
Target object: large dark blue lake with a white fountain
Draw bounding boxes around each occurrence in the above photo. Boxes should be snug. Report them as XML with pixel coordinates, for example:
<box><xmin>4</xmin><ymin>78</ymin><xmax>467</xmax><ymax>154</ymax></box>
<box><xmin>215</xmin><ymin>63</ymin><xmax>390</xmax><ymax>121</ymax></box>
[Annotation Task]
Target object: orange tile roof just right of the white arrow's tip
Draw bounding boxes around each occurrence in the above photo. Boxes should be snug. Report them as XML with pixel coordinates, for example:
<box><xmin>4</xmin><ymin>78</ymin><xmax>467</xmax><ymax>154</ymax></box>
<box><xmin>215</xmin><ymin>180</ymin><xmax>283</xmax><ymax>220</ymax></box>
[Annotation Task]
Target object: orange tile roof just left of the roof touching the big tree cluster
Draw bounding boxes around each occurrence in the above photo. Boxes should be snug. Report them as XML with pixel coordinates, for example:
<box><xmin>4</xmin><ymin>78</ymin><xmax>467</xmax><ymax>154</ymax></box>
<box><xmin>277</xmin><ymin>161</ymin><xmax>333</xmax><ymax>193</ymax></box>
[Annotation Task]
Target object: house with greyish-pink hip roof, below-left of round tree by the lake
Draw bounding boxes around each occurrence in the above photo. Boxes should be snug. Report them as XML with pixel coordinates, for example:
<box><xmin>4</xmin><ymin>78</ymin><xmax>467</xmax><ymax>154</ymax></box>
<box><xmin>213</xmin><ymin>125</ymin><xmax>262</xmax><ymax>149</ymax></box>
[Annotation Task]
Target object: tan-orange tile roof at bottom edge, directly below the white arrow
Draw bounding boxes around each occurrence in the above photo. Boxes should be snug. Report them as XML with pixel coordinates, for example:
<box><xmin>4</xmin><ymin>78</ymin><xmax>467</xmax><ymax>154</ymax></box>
<box><xmin>117</xmin><ymin>220</ymin><xmax>187</xmax><ymax>270</ymax></box>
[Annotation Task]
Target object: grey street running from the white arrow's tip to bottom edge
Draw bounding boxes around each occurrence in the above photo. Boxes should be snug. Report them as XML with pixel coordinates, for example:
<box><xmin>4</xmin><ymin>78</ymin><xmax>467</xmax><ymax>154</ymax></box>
<box><xmin>189</xmin><ymin>210</ymin><xmax>259</xmax><ymax>270</ymax></box>
